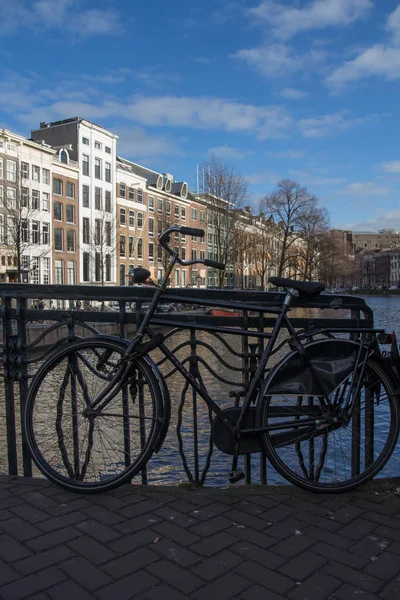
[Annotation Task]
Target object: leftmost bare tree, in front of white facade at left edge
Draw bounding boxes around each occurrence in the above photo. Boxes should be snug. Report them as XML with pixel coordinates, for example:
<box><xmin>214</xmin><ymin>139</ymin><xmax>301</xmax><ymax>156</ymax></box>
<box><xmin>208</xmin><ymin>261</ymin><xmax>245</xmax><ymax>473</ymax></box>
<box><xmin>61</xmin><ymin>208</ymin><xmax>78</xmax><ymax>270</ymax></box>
<box><xmin>0</xmin><ymin>189</ymin><xmax>50</xmax><ymax>283</ymax></box>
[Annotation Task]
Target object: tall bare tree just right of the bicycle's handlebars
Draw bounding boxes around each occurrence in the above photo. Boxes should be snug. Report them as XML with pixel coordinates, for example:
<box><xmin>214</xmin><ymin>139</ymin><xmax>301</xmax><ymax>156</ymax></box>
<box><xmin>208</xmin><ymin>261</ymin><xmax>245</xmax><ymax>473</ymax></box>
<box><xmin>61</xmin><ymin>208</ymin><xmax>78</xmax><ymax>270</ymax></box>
<box><xmin>203</xmin><ymin>155</ymin><xmax>248</xmax><ymax>287</ymax></box>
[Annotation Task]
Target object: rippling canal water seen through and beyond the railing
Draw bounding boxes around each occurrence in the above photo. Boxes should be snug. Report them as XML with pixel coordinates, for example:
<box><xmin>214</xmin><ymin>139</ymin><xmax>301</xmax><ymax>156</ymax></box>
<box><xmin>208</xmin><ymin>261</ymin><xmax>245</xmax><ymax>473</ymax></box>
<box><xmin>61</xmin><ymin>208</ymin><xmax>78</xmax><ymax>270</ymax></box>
<box><xmin>0</xmin><ymin>296</ymin><xmax>400</xmax><ymax>487</ymax></box>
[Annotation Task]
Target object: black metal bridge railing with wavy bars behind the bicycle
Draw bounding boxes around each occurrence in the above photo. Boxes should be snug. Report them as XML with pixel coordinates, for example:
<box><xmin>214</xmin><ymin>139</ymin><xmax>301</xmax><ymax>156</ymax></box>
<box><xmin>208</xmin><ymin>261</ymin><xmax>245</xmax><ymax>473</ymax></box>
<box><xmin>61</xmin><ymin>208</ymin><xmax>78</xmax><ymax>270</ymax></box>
<box><xmin>0</xmin><ymin>284</ymin><xmax>373</xmax><ymax>485</ymax></box>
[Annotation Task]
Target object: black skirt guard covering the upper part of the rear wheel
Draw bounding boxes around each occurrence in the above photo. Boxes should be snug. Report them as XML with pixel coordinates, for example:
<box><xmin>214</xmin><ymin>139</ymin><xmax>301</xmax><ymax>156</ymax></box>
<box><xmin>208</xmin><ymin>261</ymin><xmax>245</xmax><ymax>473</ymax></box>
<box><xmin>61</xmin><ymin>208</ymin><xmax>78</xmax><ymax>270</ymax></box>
<box><xmin>262</xmin><ymin>338</ymin><xmax>360</xmax><ymax>396</ymax></box>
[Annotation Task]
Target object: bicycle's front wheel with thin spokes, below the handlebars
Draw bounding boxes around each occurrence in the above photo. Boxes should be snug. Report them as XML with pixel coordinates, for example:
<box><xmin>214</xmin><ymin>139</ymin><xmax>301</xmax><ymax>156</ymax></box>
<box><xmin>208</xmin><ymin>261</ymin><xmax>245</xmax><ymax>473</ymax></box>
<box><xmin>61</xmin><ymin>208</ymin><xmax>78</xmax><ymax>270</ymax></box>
<box><xmin>25</xmin><ymin>338</ymin><xmax>163</xmax><ymax>492</ymax></box>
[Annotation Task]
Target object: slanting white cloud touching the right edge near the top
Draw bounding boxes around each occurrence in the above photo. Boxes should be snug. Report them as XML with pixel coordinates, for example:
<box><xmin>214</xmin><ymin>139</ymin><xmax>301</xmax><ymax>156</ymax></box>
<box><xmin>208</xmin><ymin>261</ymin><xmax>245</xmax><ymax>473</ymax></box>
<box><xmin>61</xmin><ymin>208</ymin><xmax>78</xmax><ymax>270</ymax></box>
<box><xmin>325</xmin><ymin>5</ymin><xmax>400</xmax><ymax>92</ymax></box>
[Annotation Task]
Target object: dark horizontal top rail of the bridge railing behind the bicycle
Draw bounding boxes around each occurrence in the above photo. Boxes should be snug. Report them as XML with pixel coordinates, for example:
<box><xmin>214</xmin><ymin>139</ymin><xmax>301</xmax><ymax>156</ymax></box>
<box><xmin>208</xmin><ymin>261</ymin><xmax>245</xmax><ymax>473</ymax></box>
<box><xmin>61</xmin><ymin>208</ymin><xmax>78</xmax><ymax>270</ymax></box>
<box><xmin>0</xmin><ymin>283</ymin><xmax>372</xmax><ymax>316</ymax></box>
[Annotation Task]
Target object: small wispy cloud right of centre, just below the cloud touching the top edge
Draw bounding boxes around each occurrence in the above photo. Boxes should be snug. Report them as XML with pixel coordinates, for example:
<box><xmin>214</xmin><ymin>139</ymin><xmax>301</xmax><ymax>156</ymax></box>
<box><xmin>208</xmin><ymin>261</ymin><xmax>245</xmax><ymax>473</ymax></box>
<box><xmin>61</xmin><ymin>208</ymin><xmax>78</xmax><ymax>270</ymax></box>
<box><xmin>231</xmin><ymin>43</ymin><xmax>327</xmax><ymax>77</ymax></box>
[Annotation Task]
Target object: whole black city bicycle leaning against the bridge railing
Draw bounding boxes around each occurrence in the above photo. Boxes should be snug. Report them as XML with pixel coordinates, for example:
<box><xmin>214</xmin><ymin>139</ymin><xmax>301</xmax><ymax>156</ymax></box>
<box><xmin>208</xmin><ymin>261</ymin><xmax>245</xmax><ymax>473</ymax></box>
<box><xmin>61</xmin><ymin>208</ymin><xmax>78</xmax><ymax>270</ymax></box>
<box><xmin>24</xmin><ymin>226</ymin><xmax>400</xmax><ymax>493</ymax></box>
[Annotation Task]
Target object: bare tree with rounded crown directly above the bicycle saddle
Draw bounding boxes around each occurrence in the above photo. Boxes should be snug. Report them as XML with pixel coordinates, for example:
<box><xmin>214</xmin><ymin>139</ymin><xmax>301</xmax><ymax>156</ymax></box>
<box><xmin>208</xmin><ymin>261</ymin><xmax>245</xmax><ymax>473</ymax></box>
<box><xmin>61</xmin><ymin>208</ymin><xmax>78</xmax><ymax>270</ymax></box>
<box><xmin>262</xmin><ymin>179</ymin><xmax>317</xmax><ymax>277</ymax></box>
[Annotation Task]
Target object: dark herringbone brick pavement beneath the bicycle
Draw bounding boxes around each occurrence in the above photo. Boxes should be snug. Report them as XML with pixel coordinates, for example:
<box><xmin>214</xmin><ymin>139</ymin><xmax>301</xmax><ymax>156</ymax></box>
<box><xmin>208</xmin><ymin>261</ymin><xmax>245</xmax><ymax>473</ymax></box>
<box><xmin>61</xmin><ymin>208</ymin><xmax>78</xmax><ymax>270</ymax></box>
<box><xmin>0</xmin><ymin>476</ymin><xmax>400</xmax><ymax>600</ymax></box>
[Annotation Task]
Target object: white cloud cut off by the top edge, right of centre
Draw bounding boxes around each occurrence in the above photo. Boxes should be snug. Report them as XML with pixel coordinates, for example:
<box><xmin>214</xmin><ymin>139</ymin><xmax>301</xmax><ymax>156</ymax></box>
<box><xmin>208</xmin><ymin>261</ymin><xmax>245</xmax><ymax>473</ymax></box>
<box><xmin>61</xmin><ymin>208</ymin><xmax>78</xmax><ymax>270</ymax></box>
<box><xmin>249</xmin><ymin>0</ymin><xmax>373</xmax><ymax>39</ymax></box>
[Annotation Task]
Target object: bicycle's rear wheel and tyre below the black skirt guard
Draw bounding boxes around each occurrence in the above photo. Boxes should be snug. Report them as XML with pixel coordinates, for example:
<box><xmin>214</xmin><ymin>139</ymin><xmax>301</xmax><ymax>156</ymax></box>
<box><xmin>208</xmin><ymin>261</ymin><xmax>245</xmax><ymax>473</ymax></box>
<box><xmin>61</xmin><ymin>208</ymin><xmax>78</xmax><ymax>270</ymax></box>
<box><xmin>258</xmin><ymin>357</ymin><xmax>400</xmax><ymax>493</ymax></box>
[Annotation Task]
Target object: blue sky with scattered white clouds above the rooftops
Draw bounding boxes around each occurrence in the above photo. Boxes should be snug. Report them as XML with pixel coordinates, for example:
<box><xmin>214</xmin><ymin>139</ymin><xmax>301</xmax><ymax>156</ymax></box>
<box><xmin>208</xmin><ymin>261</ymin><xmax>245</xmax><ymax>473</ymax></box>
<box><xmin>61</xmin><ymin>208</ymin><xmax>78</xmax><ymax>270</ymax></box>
<box><xmin>0</xmin><ymin>0</ymin><xmax>400</xmax><ymax>231</ymax></box>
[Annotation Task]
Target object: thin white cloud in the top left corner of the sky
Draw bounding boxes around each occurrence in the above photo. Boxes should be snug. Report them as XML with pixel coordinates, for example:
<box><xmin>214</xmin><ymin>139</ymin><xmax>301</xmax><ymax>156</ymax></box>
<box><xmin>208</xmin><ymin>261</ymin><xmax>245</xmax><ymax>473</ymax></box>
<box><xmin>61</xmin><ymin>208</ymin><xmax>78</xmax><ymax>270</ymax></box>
<box><xmin>0</xmin><ymin>0</ymin><xmax>122</xmax><ymax>37</ymax></box>
